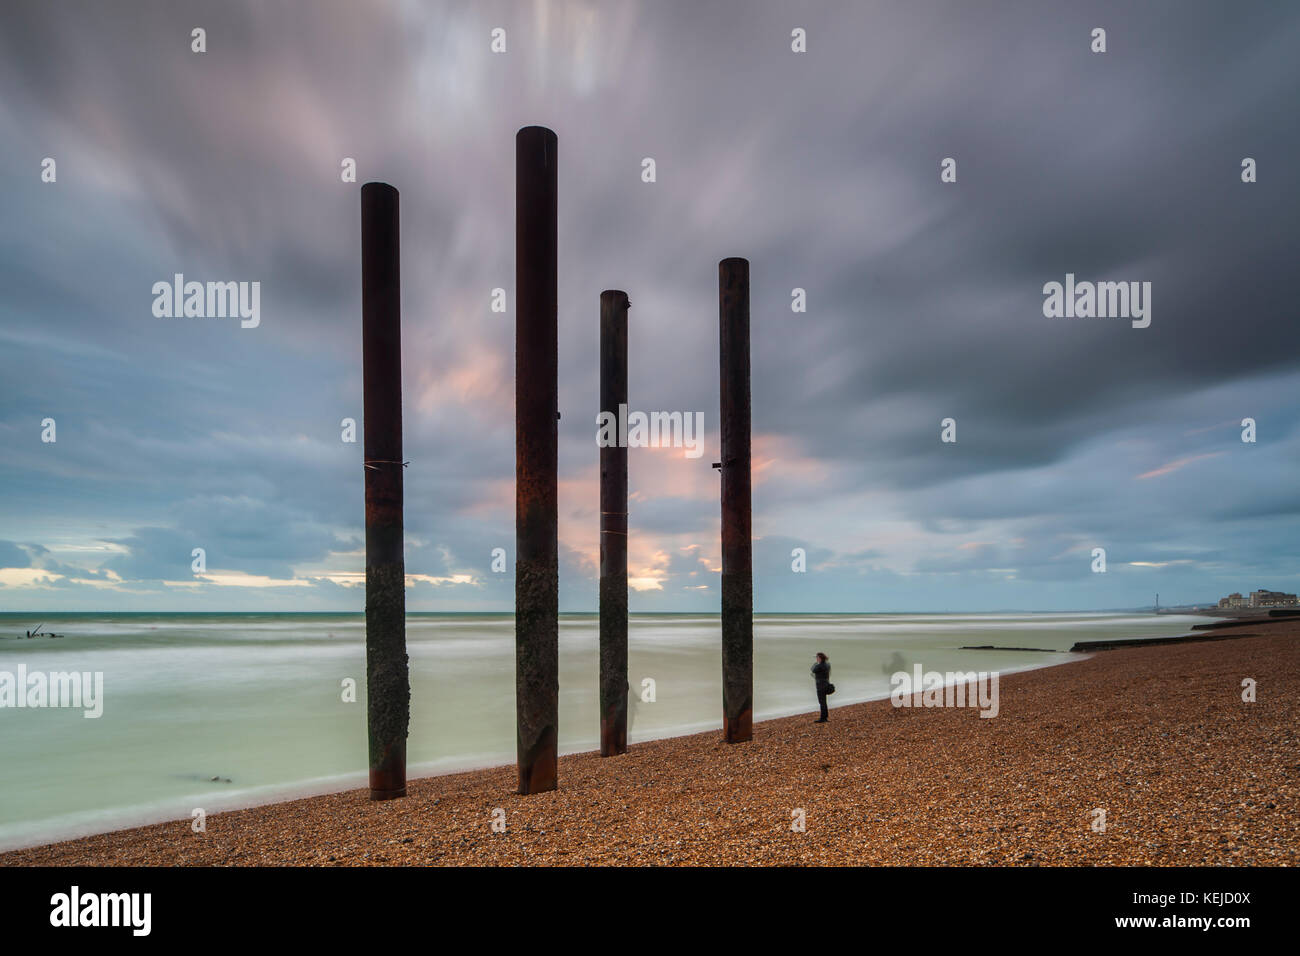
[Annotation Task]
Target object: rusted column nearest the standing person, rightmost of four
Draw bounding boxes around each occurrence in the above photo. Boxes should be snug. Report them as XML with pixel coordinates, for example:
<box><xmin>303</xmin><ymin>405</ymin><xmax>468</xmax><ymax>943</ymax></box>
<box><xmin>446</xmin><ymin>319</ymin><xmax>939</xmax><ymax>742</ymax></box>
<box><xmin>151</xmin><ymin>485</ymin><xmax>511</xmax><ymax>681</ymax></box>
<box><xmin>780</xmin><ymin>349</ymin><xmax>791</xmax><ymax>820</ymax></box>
<box><xmin>718</xmin><ymin>259</ymin><xmax>754</xmax><ymax>744</ymax></box>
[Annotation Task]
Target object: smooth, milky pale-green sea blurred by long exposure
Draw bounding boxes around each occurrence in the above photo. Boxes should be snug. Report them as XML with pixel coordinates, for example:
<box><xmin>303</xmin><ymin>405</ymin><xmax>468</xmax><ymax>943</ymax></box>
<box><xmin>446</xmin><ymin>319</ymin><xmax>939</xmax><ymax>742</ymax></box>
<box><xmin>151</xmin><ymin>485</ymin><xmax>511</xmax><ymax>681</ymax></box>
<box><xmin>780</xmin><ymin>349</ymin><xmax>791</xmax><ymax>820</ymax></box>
<box><xmin>0</xmin><ymin>614</ymin><xmax>1205</xmax><ymax>848</ymax></box>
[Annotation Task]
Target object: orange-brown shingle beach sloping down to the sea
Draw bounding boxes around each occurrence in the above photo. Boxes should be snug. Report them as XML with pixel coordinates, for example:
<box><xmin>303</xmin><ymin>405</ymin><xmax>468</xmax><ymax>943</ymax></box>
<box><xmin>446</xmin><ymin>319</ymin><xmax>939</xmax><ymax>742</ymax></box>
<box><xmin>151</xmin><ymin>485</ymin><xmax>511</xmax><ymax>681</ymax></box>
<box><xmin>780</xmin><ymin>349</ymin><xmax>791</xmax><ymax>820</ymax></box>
<box><xmin>0</xmin><ymin>622</ymin><xmax>1300</xmax><ymax>866</ymax></box>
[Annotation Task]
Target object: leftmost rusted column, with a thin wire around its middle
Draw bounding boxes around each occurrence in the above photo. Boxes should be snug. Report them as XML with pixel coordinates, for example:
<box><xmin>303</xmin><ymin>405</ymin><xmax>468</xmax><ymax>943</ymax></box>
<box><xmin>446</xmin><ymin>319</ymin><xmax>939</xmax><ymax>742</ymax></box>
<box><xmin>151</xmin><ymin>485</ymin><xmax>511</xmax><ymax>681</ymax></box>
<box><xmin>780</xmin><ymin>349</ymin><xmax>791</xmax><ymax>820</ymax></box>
<box><xmin>361</xmin><ymin>182</ymin><xmax>411</xmax><ymax>800</ymax></box>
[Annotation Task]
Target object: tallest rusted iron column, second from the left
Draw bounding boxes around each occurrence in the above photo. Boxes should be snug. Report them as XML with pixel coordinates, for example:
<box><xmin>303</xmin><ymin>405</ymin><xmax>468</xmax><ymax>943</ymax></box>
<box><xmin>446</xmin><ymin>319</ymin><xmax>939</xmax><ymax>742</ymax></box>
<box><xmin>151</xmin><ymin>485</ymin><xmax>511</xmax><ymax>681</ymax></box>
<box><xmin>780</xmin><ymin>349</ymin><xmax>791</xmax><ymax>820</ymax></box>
<box><xmin>515</xmin><ymin>126</ymin><xmax>560</xmax><ymax>793</ymax></box>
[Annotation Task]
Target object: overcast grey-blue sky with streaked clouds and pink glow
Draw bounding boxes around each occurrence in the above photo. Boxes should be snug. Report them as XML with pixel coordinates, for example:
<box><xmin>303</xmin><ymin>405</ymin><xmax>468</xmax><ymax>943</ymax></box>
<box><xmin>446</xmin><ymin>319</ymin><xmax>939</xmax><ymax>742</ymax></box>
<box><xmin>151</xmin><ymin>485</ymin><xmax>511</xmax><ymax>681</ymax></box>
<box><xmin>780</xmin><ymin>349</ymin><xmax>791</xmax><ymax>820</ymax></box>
<box><xmin>0</xmin><ymin>0</ymin><xmax>1300</xmax><ymax>611</ymax></box>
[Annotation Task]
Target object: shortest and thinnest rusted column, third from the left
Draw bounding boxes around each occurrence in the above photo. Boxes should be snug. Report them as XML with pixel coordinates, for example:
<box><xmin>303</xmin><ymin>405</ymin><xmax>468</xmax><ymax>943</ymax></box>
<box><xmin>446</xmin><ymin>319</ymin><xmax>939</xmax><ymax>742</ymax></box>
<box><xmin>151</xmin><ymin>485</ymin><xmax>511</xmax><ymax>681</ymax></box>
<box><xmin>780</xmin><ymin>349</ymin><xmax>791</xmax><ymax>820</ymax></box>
<box><xmin>601</xmin><ymin>290</ymin><xmax>628</xmax><ymax>757</ymax></box>
